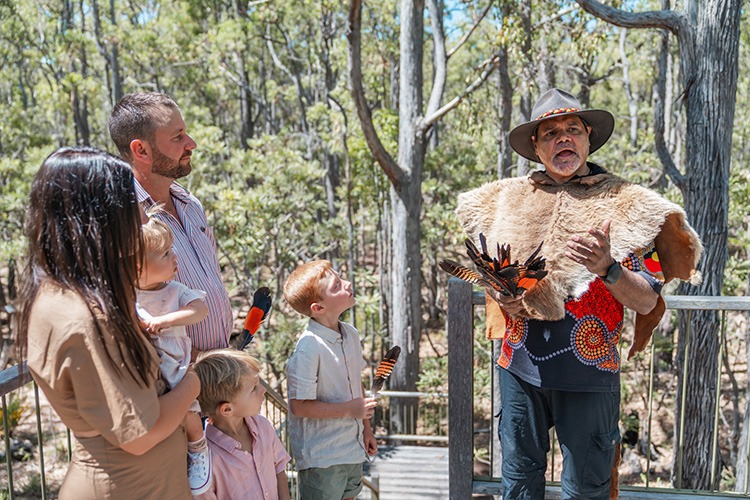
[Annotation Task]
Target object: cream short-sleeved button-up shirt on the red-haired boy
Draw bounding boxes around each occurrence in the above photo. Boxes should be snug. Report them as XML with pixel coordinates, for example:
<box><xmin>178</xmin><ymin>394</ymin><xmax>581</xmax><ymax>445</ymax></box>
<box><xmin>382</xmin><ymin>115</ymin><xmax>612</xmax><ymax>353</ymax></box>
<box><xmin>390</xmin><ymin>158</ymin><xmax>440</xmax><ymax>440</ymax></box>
<box><xmin>287</xmin><ymin>319</ymin><xmax>367</xmax><ymax>470</ymax></box>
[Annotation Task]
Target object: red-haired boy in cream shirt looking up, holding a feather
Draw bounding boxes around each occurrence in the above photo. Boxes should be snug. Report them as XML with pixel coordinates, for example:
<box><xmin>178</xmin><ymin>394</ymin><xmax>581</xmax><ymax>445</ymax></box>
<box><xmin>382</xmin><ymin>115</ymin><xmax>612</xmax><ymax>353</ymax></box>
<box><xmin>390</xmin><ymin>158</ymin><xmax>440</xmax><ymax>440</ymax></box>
<box><xmin>284</xmin><ymin>260</ymin><xmax>378</xmax><ymax>500</ymax></box>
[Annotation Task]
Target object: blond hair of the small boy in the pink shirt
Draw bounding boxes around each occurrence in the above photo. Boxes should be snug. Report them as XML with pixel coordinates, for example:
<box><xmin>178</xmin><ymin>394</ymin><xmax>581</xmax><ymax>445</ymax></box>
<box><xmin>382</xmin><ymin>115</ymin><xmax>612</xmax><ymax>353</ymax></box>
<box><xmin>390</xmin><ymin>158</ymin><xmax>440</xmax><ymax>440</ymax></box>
<box><xmin>193</xmin><ymin>349</ymin><xmax>260</xmax><ymax>417</ymax></box>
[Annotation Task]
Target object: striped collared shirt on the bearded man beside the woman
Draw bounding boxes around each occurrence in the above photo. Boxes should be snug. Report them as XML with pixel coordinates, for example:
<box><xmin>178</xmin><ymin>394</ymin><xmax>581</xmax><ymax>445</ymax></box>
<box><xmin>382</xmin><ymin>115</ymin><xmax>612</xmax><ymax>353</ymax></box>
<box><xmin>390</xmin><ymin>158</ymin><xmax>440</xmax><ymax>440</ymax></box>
<box><xmin>135</xmin><ymin>181</ymin><xmax>232</xmax><ymax>351</ymax></box>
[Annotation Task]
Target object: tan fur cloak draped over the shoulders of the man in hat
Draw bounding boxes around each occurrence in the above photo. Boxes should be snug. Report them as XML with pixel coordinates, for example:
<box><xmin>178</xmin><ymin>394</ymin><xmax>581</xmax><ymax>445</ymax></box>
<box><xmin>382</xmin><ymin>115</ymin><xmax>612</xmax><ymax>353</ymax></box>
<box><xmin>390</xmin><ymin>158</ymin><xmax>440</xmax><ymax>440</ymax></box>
<box><xmin>456</xmin><ymin>171</ymin><xmax>703</xmax><ymax>358</ymax></box>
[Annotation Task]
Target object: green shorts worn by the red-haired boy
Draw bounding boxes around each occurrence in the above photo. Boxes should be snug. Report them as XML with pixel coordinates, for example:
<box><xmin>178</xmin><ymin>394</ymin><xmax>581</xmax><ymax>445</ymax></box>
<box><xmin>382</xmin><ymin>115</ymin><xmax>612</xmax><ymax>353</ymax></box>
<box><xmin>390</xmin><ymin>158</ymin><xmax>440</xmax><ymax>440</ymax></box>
<box><xmin>299</xmin><ymin>464</ymin><xmax>362</xmax><ymax>500</ymax></box>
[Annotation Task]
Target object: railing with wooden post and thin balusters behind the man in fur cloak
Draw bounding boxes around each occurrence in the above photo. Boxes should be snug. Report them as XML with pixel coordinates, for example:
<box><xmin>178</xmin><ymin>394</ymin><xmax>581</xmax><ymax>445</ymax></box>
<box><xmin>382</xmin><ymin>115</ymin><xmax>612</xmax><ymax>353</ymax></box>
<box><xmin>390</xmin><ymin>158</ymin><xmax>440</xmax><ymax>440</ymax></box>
<box><xmin>447</xmin><ymin>278</ymin><xmax>750</xmax><ymax>500</ymax></box>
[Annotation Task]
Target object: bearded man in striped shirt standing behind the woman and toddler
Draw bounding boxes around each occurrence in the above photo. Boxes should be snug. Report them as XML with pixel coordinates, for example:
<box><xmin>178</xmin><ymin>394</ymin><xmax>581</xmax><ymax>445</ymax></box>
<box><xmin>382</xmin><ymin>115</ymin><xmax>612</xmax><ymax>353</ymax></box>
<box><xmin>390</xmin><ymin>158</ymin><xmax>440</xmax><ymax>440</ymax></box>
<box><xmin>109</xmin><ymin>92</ymin><xmax>232</xmax><ymax>357</ymax></box>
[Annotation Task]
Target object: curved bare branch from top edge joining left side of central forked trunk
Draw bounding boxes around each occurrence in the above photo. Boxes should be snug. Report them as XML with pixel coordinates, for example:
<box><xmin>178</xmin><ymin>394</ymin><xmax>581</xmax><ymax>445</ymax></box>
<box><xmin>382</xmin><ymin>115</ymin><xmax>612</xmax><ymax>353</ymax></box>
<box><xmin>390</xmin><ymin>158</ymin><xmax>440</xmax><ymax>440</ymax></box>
<box><xmin>346</xmin><ymin>0</ymin><xmax>407</xmax><ymax>187</ymax></box>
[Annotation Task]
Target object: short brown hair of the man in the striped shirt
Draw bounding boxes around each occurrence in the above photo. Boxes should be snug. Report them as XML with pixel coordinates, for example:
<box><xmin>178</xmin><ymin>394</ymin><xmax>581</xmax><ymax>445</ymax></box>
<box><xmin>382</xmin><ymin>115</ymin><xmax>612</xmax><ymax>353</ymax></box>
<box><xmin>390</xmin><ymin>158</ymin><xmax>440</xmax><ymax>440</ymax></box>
<box><xmin>109</xmin><ymin>92</ymin><xmax>179</xmax><ymax>159</ymax></box>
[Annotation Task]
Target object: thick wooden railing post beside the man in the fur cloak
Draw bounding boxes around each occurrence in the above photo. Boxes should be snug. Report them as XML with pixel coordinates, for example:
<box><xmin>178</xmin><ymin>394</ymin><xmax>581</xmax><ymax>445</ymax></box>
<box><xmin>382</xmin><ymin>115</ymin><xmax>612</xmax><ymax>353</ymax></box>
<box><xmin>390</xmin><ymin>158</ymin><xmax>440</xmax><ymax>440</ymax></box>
<box><xmin>448</xmin><ymin>278</ymin><xmax>474</xmax><ymax>500</ymax></box>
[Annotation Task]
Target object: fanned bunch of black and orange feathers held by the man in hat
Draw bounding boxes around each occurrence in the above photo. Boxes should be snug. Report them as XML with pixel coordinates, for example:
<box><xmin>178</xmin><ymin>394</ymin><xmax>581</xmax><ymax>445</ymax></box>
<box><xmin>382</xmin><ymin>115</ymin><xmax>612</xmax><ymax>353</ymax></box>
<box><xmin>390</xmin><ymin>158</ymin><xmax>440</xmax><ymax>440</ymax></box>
<box><xmin>440</xmin><ymin>233</ymin><xmax>547</xmax><ymax>297</ymax></box>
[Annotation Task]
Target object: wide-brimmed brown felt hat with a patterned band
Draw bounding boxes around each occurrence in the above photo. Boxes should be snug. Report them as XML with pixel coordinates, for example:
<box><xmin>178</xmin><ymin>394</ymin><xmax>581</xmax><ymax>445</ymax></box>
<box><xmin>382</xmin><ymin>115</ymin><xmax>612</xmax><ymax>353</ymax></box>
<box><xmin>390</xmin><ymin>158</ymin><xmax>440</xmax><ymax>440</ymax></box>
<box><xmin>508</xmin><ymin>89</ymin><xmax>615</xmax><ymax>163</ymax></box>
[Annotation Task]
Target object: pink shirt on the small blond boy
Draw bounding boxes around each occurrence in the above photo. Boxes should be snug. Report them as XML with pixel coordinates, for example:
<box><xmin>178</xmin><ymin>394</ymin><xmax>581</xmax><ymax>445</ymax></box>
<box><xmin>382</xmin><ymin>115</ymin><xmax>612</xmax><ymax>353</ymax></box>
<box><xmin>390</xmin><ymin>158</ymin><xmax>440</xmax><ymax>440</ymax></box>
<box><xmin>194</xmin><ymin>415</ymin><xmax>292</xmax><ymax>500</ymax></box>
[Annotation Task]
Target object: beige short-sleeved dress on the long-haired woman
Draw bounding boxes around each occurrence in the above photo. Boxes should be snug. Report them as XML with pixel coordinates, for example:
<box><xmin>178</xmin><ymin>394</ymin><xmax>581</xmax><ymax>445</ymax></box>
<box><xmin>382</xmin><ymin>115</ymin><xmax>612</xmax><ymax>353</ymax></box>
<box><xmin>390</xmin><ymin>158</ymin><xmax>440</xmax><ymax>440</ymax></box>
<box><xmin>27</xmin><ymin>284</ymin><xmax>190</xmax><ymax>500</ymax></box>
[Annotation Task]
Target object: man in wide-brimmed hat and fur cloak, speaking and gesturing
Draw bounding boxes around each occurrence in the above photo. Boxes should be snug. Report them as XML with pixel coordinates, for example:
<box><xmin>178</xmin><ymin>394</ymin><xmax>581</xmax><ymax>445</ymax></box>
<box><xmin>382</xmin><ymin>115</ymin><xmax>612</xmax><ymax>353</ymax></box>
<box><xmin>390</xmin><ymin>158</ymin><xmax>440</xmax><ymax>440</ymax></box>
<box><xmin>457</xmin><ymin>89</ymin><xmax>702</xmax><ymax>499</ymax></box>
